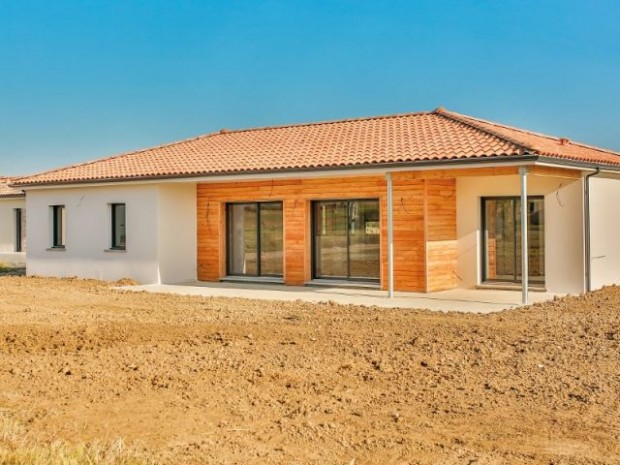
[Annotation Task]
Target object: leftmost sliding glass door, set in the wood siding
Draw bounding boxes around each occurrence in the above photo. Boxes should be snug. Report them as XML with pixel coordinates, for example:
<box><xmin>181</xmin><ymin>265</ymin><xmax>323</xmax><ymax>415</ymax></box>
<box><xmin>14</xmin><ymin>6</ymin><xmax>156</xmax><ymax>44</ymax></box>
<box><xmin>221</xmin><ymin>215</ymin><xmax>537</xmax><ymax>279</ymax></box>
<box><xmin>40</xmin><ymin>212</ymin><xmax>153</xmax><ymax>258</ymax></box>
<box><xmin>227</xmin><ymin>202</ymin><xmax>283</xmax><ymax>277</ymax></box>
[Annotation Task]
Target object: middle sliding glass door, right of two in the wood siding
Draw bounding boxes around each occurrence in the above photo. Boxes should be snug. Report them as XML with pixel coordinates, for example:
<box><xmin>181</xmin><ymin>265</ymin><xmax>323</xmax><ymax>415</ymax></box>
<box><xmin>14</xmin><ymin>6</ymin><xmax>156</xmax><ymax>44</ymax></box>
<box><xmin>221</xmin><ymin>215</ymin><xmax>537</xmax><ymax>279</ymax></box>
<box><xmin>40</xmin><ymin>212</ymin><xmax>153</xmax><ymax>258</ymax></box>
<box><xmin>312</xmin><ymin>200</ymin><xmax>380</xmax><ymax>281</ymax></box>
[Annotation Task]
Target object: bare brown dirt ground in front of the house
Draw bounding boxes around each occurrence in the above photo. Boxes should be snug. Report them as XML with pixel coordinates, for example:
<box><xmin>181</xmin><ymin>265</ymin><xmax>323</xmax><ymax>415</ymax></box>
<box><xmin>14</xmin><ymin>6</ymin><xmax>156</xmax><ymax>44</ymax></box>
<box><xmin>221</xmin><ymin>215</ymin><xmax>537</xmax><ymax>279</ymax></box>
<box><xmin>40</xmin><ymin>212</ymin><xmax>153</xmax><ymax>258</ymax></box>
<box><xmin>0</xmin><ymin>277</ymin><xmax>620</xmax><ymax>465</ymax></box>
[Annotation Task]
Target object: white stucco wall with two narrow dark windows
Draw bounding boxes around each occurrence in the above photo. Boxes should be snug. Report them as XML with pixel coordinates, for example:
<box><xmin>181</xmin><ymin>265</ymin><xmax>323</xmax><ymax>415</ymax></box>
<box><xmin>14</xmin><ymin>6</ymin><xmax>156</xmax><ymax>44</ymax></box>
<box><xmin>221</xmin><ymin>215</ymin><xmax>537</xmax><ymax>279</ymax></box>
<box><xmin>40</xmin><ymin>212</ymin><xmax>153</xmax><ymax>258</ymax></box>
<box><xmin>26</xmin><ymin>184</ymin><xmax>196</xmax><ymax>283</ymax></box>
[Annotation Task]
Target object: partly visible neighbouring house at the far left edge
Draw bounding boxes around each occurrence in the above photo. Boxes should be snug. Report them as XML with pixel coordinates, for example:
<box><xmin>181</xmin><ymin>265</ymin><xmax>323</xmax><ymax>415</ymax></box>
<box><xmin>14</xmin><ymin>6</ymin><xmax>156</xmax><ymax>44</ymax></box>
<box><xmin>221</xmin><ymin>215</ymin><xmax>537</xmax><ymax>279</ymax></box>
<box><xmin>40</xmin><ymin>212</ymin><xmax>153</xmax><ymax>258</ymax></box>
<box><xmin>0</xmin><ymin>177</ymin><xmax>26</xmax><ymax>266</ymax></box>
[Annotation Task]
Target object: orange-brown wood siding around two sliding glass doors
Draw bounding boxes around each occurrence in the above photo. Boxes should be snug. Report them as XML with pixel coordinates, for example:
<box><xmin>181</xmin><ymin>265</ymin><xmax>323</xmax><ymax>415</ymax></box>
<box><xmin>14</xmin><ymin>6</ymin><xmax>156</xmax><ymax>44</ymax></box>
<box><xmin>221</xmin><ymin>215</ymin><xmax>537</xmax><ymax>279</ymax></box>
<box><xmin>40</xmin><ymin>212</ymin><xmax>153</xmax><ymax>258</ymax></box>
<box><xmin>197</xmin><ymin>173</ymin><xmax>457</xmax><ymax>291</ymax></box>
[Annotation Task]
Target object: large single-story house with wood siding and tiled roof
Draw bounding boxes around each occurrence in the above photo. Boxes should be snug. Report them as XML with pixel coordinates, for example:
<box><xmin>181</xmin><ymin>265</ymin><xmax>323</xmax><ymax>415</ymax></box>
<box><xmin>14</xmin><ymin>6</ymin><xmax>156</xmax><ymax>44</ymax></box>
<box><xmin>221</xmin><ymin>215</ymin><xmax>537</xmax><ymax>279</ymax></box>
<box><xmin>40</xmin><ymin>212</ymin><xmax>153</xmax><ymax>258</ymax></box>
<box><xmin>14</xmin><ymin>108</ymin><xmax>620</xmax><ymax>297</ymax></box>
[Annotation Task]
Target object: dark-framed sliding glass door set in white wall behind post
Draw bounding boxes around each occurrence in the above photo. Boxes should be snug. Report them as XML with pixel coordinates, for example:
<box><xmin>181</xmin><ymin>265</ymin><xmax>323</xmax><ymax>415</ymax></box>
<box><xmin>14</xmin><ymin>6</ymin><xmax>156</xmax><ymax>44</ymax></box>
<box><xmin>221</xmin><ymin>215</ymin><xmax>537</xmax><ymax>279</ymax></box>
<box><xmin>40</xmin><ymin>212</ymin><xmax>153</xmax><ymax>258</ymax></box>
<box><xmin>482</xmin><ymin>197</ymin><xmax>545</xmax><ymax>283</ymax></box>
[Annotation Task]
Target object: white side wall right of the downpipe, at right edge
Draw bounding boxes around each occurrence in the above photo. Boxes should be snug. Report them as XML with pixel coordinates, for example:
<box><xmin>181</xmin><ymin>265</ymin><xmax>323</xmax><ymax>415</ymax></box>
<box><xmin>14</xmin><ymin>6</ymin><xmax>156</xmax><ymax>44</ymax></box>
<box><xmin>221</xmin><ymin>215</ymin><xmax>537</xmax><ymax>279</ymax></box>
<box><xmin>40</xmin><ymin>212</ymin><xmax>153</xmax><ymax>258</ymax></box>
<box><xmin>590</xmin><ymin>177</ymin><xmax>620</xmax><ymax>290</ymax></box>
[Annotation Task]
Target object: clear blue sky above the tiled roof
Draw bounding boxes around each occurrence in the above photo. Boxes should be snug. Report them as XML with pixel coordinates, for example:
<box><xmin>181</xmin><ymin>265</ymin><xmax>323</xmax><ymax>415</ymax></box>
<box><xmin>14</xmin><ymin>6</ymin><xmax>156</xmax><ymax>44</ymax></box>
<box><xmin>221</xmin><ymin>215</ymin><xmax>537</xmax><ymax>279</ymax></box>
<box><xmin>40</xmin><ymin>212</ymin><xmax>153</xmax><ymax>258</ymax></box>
<box><xmin>0</xmin><ymin>0</ymin><xmax>620</xmax><ymax>175</ymax></box>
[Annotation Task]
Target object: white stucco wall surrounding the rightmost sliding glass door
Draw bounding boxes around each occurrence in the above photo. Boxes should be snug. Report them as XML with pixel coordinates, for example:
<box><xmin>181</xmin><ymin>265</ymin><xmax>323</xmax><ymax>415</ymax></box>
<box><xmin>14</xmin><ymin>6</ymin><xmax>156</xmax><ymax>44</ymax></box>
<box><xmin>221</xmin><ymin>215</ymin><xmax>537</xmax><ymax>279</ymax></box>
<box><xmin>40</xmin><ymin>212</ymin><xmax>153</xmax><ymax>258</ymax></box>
<box><xmin>457</xmin><ymin>175</ymin><xmax>585</xmax><ymax>294</ymax></box>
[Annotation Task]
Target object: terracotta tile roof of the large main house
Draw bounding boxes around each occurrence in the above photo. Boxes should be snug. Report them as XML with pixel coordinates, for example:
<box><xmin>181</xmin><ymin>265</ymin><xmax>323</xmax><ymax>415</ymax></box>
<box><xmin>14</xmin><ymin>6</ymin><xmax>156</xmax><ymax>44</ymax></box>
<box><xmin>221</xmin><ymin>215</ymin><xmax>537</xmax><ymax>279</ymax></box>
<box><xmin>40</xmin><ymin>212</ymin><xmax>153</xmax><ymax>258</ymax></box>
<box><xmin>15</xmin><ymin>108</ymin><xmax>620</xmax><ymax>185</ymax></box>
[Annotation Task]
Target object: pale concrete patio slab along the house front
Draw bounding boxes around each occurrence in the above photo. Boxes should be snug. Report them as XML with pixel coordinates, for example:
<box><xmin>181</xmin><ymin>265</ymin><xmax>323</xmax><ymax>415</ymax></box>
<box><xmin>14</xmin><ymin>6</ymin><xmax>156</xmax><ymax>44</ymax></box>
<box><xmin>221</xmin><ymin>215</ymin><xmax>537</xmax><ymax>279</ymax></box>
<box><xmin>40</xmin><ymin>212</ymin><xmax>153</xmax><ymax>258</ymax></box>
<box><xmin>117</xmin><ymin>282</ymin><xmax>556</xmax><ymax>313</ymax></box>
